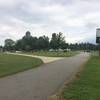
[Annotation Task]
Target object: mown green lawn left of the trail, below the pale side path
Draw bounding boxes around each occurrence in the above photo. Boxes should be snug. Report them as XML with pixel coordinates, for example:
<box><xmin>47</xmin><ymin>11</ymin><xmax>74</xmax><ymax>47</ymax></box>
<box><xmin>0</xmin><ymin>54</ymin><xmax>43</xmax><ymax>77</ymax></box>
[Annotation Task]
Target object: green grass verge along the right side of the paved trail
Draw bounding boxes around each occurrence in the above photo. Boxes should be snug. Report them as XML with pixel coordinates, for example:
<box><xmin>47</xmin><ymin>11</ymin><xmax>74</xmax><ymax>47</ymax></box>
<box><xmin>61</xmin><ymin>56</ymin><xmax>100</xmax><ymax>100</ymax></box>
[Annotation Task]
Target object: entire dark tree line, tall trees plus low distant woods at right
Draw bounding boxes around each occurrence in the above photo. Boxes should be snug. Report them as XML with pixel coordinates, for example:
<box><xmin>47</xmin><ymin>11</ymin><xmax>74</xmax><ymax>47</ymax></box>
<box><xmin>3</xmin><ymin>31</ymin><xmax>97</xmax><ymax>51</ymax></box>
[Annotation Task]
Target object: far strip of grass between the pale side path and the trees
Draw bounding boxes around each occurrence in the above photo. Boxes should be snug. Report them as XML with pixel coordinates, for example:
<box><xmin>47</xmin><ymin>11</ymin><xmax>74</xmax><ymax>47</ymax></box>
<box><xmin>22</xmin><ymin>51</ymin><xmax>79</xmax><ymax>57</ymax></box>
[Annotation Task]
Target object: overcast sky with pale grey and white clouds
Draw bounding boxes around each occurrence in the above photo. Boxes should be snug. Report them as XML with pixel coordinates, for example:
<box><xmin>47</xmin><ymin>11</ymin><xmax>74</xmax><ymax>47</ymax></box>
<box><xmin>0</xmin><ymin>0</ymin><xmax>100</xmax><ymax>44</ymax></box>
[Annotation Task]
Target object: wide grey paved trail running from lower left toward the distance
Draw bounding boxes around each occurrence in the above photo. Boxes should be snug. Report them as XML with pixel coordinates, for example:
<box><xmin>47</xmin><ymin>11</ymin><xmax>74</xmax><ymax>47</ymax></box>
<box><xmin>0</xmin><ymin>53</ymin><xmax>89</xmax><ymax>100</ymax></box>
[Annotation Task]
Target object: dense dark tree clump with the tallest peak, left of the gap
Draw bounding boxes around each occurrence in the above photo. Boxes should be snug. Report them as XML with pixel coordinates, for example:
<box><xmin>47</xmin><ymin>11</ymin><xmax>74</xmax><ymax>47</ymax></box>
<box><xmin>16</xmin><ymin>31</ymin><xmax>49</xmax><ymax>51</ymax></box>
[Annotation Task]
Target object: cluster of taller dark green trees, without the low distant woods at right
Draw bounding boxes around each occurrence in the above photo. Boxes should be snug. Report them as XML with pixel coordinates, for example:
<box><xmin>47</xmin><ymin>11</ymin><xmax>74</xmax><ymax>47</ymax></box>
<box><xmin>4</xmin><ymin>31</ymin><xmax>67</xmax><ymax>51</ymax></box>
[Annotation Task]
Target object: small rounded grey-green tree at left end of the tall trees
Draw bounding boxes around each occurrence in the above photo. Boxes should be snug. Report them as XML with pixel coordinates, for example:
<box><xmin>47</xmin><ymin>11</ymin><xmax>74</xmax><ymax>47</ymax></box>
<box><xmin>4</xmin><ymin>39</ymin><xmax>15</xmax><ymax>51</ymax></box>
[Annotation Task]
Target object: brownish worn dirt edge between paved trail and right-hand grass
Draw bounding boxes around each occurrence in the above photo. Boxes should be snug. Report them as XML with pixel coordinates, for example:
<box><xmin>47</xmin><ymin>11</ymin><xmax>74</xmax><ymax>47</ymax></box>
<box><xmin>47</xmin><ymin>55</ymin><xmax>91</xmax><ymax>100</ymax></box>
